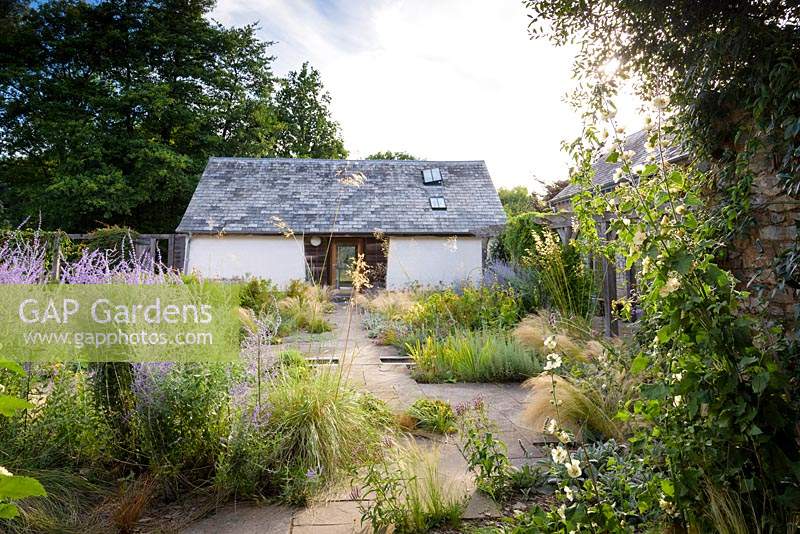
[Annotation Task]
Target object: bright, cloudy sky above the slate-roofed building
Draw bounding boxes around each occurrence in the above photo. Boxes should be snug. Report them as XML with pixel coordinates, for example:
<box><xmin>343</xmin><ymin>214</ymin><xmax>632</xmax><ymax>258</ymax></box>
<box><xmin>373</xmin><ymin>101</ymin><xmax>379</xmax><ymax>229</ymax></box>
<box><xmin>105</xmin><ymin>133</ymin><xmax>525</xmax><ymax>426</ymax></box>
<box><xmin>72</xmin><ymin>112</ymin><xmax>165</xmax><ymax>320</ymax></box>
<box><xmin>211</xmin><ymin>0</ymin><xmax>637</xmax><ymax>190</ymax></box>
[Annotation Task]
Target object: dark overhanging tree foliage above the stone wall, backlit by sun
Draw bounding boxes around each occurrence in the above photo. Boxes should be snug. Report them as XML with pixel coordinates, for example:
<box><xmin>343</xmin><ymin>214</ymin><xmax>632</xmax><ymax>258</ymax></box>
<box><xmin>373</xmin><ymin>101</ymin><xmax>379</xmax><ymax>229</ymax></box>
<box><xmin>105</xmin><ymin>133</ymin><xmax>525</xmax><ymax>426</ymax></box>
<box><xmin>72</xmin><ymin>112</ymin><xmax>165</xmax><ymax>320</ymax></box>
<box><xmin>526</xmin><ymin>0</ymin><xmax>800</xmax><ymax>214</ymax></box>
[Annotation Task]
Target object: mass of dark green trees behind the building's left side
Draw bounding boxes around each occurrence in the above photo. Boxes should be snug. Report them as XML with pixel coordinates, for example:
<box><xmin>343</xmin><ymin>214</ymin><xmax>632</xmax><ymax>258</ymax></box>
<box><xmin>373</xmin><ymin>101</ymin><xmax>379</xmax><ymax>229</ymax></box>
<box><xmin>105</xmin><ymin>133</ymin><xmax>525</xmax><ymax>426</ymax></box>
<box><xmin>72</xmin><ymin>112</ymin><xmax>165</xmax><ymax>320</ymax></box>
<box><xmin>0</xmin><ymin>0</ymin><xmax>345</xmax><ymax>232</ymax></box>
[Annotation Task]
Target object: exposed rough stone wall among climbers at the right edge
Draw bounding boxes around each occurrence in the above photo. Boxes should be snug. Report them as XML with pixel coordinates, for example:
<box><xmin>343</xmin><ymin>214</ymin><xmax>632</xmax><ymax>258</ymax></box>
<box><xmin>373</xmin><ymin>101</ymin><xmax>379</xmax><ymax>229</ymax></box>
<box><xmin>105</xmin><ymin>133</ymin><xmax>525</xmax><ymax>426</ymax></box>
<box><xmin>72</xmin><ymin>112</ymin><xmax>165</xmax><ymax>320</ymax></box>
<box><xmin>723</xmin><ymin>158</ymin><xmax>800</xmax><ymax>325</ymax></box>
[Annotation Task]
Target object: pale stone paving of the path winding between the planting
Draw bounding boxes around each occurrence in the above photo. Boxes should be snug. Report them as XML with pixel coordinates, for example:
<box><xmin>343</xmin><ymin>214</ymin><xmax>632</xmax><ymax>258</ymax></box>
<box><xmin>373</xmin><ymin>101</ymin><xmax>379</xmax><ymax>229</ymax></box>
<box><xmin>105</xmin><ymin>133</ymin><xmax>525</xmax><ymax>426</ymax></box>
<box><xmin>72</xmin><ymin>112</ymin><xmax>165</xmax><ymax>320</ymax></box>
<box><xmin>184</xmin><ymin>304</ymin><xmax>542</xmax><ymax>534</ymax></box>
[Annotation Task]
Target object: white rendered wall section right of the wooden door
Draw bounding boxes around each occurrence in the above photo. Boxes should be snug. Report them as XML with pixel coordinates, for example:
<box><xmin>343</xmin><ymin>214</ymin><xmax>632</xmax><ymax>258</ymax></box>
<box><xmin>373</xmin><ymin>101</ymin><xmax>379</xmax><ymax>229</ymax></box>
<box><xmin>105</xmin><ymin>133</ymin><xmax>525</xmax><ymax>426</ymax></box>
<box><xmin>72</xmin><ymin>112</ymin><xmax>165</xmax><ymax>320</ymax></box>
<box><xmin>386</xmin><ymin>237</ymin><xmax>483</xmax><ymax>289</ymax></box>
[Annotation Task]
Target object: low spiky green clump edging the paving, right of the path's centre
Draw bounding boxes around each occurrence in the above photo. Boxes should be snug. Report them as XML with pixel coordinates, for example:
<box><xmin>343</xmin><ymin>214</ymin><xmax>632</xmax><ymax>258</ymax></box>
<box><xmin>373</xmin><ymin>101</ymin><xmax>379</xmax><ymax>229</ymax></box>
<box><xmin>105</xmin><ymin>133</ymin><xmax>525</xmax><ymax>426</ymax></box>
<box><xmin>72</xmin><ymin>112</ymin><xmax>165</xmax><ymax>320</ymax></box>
<box><xmin>406</xmin><ymin>330</ymin><xmax>542</xmax><ymax>382</ymax></box>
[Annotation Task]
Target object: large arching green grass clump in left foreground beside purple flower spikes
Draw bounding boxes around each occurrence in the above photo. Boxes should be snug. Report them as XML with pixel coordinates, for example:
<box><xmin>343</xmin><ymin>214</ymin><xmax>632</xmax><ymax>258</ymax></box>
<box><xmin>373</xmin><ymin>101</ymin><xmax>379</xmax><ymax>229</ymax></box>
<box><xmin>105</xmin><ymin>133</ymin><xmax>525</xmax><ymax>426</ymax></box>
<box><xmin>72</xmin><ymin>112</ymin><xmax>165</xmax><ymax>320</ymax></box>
<box><xmin>214</xmin><ymin>360</ymin><xmax>394</xmax><ymax>504</ymax></box>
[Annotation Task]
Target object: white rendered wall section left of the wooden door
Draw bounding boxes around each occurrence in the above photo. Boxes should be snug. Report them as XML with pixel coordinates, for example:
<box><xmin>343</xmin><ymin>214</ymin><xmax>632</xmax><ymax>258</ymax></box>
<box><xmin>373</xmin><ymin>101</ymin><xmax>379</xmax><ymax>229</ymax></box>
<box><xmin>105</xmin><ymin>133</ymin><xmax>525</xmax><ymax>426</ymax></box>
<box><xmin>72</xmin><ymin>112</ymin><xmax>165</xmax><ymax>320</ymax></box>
<box><xmin>186</xmin><ymin>235</ymin><xmax>306</xmax><ymax>287</ymax></box>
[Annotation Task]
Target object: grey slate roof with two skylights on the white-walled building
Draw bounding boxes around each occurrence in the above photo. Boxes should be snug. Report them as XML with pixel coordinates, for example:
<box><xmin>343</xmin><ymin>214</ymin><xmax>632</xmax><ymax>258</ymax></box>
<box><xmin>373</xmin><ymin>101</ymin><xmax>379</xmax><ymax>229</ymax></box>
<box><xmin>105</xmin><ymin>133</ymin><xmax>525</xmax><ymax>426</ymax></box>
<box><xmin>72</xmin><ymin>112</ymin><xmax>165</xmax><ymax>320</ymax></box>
<box><xmin>177</xmin><ymin>158</ymin><xmax>506</xmax><ymax>235</ymax></box>
